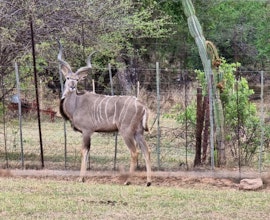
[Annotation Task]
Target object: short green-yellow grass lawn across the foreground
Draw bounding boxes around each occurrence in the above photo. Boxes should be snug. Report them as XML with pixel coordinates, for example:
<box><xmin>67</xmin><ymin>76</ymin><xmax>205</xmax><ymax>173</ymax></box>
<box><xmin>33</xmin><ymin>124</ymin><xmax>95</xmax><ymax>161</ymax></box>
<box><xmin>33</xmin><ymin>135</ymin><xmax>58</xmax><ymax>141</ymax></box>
<box><xmin>0</xmin><ymin>178</ymin><xmax>270</xmax><ymax>219</ymax></box>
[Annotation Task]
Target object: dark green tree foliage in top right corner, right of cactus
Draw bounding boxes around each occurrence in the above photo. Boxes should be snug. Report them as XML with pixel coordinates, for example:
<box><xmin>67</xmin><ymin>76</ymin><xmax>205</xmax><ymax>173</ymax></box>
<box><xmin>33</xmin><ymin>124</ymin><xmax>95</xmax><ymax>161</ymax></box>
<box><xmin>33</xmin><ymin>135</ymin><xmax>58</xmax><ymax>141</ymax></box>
<box><xmin>198</xmin><ymin>0</ymin><xmax>270</xmax><ymax>67</ymax></box>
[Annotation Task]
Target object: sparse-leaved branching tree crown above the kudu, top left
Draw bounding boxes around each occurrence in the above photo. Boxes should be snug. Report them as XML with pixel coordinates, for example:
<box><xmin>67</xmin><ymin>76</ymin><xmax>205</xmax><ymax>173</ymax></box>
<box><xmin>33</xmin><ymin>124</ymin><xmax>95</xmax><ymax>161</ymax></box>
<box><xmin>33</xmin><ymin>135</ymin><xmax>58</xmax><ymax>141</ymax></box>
<box><xmin>0</xmin><ymin>0</ymin><xmax>173</xmax><ymax>97</ymax></box>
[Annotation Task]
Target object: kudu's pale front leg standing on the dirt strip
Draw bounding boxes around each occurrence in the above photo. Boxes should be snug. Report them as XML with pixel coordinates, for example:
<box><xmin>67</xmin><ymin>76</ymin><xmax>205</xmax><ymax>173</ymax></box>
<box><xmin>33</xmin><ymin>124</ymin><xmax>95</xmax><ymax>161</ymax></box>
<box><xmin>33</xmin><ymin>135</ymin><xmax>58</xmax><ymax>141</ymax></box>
<box><xmin>80</xmin><ymin>135</ymin><xmax>91</xmax><ymax>182</ymax></box>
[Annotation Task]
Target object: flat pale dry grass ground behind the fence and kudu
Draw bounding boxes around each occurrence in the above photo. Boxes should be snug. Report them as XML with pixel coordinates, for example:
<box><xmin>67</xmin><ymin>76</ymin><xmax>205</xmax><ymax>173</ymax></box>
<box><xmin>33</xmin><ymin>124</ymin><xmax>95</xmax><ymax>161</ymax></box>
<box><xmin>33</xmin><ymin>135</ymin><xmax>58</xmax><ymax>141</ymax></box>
<box><xmin>0</xmin><ymin>115</ymin><xmax>193</xmax><ymax>170</ymax></box>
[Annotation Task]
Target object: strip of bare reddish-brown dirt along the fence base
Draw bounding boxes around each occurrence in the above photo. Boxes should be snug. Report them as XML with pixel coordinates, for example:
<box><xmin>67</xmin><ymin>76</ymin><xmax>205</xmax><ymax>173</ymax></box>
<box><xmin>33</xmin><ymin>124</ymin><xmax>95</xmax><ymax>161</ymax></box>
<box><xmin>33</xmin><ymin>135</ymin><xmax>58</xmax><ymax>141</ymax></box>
<box><xmin>0</xmin><ymin>169</ymin><xmax>270</xmax><ymax>192</ymax></box>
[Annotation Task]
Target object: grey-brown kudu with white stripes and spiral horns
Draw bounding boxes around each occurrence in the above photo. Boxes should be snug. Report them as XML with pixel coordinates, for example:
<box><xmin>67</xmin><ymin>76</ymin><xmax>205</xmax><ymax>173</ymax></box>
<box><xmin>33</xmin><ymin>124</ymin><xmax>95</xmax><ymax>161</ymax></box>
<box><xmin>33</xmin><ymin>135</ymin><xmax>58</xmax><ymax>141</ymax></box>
<box><xmin>57</xmin><ymin>43</ymin><xmax>151</xmax><ymax>186</ymax></box>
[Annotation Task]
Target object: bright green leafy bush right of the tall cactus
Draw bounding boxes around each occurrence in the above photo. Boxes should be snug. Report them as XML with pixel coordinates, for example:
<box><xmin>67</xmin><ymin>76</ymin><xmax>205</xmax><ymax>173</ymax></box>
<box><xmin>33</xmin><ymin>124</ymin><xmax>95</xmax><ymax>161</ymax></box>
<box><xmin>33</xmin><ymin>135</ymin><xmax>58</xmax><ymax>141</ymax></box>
<box><xmin>213</xmin><ymin>59</ymin><xmax>260</xmax><ymax>164</ymax></box>
